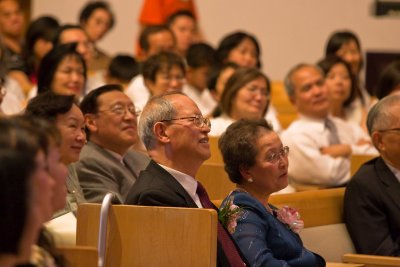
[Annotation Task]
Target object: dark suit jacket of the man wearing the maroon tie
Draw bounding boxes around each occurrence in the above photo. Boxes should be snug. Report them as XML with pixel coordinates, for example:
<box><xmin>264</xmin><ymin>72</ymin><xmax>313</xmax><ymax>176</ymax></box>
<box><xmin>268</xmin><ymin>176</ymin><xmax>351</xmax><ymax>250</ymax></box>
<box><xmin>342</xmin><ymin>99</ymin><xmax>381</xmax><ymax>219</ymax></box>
<box><xmin>125</xmin><ymin>161</ymin><xmax>249</xmax><ymax>266</ymax></box>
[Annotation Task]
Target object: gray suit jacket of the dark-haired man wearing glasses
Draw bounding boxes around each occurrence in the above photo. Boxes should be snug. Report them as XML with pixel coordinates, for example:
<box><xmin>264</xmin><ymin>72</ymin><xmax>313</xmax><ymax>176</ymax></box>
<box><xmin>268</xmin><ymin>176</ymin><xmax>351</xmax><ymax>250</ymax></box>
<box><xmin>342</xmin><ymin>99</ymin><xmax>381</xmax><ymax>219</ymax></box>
<box><xmin>76</xmin><ymin>142</ymin><xmax>150</xmax><ymax>203</ymax></box>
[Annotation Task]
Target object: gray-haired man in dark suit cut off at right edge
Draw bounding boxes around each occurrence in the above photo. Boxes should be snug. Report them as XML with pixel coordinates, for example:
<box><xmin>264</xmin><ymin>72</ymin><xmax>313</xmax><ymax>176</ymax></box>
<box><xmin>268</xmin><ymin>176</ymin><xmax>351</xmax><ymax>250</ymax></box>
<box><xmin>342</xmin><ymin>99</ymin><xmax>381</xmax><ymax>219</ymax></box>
<box><xmin>344</xmin><ymin>95</ymin><xmax>400</xmax><ymax>257</ymax></box>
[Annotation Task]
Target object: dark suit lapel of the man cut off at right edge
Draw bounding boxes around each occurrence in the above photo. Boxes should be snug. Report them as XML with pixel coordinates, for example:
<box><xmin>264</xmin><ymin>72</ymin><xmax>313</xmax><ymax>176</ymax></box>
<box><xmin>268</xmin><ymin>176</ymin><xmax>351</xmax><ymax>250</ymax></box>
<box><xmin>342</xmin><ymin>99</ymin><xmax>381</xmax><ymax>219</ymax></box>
<box><xmin>375</xmin><ymin>158</ymin><xmax>400</xmax><ymax>209</ymax></box>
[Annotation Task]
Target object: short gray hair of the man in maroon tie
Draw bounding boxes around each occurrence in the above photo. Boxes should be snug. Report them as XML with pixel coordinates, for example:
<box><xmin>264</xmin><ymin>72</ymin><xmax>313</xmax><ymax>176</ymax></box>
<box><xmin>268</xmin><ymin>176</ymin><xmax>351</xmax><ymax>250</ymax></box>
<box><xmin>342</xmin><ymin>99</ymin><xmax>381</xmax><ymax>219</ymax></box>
<box><xmin>138</xmin><ymin>92</ymin><xmax>185</xmax><ymax>150</ymax></box>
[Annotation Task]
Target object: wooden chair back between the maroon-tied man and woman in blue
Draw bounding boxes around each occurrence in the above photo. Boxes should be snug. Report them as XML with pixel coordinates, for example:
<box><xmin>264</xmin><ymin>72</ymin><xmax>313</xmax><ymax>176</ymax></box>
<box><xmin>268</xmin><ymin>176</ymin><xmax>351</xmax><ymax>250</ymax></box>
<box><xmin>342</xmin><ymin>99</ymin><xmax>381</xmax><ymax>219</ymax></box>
<box><xmin>196</xmin><ymin>163</ymin><xmax>236</xmax><ymax>199</ymax></box>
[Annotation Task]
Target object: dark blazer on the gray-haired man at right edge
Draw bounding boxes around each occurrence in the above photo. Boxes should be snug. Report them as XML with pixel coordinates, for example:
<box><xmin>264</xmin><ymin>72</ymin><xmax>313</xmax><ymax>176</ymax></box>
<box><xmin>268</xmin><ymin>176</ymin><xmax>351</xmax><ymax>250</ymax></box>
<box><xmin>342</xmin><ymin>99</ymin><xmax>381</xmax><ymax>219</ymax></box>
<box><xmin>344</xmin><ymin>157</ymin><xmax>400</xmax><ymax>256</ymax></box>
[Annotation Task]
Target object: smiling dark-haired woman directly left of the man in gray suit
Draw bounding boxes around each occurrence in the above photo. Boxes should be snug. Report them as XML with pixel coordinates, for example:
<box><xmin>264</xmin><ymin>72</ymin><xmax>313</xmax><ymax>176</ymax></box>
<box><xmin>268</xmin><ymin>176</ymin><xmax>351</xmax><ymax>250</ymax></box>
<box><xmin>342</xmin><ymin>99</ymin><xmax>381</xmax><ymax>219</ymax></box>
<box><xmin>25</xmin><ymin>91</ymin><xmax>86</xmax><ymax>214</ymax></box>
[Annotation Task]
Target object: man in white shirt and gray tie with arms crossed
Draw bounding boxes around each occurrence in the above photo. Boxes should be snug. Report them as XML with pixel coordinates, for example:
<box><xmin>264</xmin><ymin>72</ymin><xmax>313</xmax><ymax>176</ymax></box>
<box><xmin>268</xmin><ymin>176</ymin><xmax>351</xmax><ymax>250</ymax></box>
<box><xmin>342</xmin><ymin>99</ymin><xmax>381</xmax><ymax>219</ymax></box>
<box><xmin>281</xmin><ymin>63</ymin><xmax>377</xmax><ymax>189</ymax></box>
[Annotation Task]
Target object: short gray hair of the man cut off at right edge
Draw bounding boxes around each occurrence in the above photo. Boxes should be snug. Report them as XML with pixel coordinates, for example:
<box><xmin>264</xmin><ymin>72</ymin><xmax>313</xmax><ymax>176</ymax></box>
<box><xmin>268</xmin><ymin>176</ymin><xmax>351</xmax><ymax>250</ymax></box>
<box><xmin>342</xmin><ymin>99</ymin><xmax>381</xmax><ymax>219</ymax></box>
<box><xmin>367</xmin><ymin>95</ymin><xmax>400</xmax><ymax>136</ymax></box>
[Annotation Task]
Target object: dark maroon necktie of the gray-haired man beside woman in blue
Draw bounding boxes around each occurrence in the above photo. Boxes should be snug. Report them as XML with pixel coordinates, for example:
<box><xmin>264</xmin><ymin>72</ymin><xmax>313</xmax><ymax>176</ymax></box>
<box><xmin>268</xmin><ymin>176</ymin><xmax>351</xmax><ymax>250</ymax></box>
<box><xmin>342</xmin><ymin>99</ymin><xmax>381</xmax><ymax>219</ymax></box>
<box><xmin>196</xmin><ymin>182</ymin><xmax>246</xmax><ymax>267</ymax></box>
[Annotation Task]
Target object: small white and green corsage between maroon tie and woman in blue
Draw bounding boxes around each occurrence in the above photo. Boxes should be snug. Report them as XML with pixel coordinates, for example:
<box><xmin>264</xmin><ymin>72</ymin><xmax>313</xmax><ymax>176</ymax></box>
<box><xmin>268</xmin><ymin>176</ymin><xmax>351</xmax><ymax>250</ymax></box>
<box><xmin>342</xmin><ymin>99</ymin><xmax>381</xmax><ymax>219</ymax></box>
<box><xmin>218</xmin><ymin>196</ymin><xmax>244</xmax><ymax>234</ymax></box>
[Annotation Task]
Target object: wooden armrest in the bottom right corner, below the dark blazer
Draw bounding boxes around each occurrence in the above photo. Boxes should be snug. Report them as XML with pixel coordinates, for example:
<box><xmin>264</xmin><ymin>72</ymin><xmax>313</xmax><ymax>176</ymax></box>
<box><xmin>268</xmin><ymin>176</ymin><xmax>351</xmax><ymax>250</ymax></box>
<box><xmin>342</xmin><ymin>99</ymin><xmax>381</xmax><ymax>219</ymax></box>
<box><xmin>343</xmin><ymin>253</ymin><xmax>400</xmax><ymax>267</ymax></box>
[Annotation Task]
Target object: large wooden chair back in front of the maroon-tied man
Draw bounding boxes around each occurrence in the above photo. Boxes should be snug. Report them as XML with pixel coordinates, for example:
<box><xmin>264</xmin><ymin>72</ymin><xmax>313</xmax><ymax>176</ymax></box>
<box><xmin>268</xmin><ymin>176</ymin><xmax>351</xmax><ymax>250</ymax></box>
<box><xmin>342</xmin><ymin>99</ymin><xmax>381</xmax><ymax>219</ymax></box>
<box><xmin>77</xmin><ymin>204</ymin><xmax>217</xmax><ymax>267</ymax></box>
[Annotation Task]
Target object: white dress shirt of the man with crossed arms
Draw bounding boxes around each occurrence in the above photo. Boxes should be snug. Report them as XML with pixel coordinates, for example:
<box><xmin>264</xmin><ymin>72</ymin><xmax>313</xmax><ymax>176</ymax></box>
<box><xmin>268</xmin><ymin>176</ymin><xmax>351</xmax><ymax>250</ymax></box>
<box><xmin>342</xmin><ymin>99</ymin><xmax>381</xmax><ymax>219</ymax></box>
<box><xmin>281</xmin><ymin>116</ymin><xmax>378</xmax><ymax>187</ymax></box>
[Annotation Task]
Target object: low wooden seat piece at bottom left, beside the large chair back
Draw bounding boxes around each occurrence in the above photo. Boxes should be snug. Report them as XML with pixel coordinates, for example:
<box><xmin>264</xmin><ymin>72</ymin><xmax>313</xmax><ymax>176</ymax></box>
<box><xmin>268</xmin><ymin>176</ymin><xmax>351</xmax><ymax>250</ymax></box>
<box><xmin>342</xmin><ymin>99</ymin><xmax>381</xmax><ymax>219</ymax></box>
<box><xmin>57</xmin><ymin>246</ymin><xmax>98</xmax><ymax>267</ymax></box>
